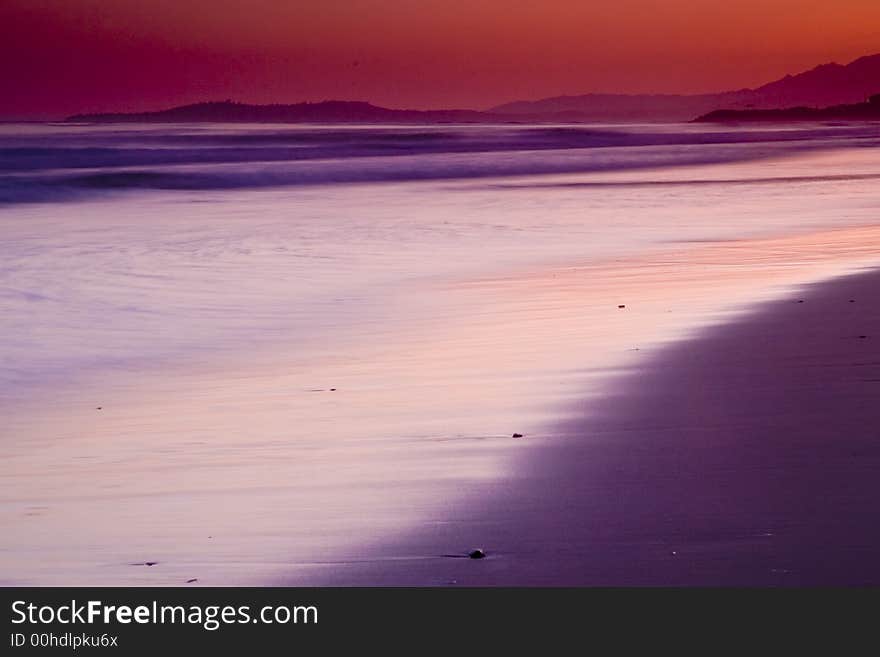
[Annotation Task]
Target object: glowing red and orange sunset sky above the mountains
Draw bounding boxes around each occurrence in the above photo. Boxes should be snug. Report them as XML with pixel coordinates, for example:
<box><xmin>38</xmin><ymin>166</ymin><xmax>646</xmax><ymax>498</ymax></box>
<box><xmin>0</xmin><ymin>0</ymin><xmax>880</xmax><ymax>119</ymax></box>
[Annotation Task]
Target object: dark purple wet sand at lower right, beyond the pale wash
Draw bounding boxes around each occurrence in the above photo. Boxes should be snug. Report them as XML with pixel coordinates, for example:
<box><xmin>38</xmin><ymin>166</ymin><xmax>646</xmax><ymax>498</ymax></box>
<box><xmin>314</xmin><ymin>271</ymin><xmax>880</xmax><ymax>586</ymax></box>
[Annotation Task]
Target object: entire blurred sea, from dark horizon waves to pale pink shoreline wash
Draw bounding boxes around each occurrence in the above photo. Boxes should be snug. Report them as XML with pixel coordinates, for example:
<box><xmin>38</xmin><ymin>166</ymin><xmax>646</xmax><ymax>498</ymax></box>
<box><xmin>0</xmin><ymin>124</ymin><xmax>880</xmax><ymax>585</ymax></box>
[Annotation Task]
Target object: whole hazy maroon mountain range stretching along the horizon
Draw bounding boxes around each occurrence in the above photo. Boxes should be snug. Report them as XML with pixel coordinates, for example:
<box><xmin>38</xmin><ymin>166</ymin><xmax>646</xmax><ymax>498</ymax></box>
<box><xmin>67</xmin><ymin>54</ymin><xmax>880</xmax><ymax>123</ymax></box>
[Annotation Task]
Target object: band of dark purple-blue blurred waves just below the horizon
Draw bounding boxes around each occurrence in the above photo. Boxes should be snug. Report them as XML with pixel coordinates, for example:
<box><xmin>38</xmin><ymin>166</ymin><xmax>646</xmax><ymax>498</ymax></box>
<box><xmin>0</xmin><ymin>125</ymin><xmax>880</xmax><ymax>204</ymax></box>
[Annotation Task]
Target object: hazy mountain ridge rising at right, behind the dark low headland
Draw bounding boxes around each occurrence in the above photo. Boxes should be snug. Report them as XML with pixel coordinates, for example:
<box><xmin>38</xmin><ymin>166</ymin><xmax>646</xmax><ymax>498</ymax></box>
<box><xmin>489</xmin><ymin>54</ymin><xmax>880</xmax><ymax>121</ymax></box>
